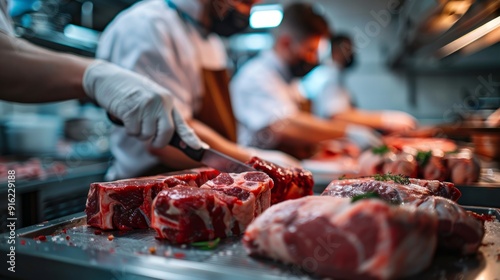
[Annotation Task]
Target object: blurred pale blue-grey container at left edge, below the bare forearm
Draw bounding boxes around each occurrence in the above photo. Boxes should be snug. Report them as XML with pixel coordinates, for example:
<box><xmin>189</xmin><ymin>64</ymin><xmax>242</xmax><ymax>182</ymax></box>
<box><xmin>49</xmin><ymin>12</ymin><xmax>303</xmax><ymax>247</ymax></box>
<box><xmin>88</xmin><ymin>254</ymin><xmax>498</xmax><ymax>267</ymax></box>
<box><xmin>4</xmin><ymin>114</ymin><xmax>61</xmax><ymax>155</ymax></box>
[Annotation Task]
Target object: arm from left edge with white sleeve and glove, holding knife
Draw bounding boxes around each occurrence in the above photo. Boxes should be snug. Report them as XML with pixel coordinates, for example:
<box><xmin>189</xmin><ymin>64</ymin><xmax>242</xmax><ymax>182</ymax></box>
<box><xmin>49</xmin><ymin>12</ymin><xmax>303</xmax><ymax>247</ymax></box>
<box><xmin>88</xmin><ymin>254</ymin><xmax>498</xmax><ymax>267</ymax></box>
<box><xmin>0</xmin><ymin>0</ymin><xmax>202</xmax><ymax>149</ymax></box>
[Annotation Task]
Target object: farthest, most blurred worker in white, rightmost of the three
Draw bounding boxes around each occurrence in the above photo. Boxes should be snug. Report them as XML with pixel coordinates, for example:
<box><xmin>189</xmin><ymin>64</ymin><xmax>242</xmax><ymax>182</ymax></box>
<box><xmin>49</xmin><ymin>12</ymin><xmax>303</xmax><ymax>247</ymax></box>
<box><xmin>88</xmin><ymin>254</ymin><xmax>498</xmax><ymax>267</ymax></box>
<box><xmin>300</xmin><ymin>34</ymin><xmax>417</xmax><ymax>132</ymax></box>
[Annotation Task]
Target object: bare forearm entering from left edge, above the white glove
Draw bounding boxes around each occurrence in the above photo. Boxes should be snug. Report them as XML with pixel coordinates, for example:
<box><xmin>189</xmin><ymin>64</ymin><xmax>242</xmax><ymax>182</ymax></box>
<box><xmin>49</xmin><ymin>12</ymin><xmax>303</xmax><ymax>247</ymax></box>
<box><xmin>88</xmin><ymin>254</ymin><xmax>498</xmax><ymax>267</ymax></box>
<box><xmin>0</xmin><ymin>33</ymin><xmax>92</xmax><ymax>103</ymax></box>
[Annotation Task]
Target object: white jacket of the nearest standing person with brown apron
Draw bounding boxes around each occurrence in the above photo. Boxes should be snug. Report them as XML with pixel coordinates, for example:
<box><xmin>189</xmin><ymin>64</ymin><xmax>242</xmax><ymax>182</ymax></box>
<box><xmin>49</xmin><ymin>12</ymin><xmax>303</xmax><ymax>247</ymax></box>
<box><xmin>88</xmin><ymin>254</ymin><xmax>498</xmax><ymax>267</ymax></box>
<box><xmin>97</xmin><ymin>0</ymin><xmax>227</xmax><ymax>180</ymax></box>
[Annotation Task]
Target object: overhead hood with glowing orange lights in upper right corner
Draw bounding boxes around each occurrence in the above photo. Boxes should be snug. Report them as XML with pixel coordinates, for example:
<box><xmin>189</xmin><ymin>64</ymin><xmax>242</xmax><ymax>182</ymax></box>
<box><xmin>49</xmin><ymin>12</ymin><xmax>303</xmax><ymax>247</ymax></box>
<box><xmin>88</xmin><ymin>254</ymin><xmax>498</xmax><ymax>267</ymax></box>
<box><xmin>389</xmin><ymin>0</ymin><xmax>500</xmax><ymax>71</ymax></box>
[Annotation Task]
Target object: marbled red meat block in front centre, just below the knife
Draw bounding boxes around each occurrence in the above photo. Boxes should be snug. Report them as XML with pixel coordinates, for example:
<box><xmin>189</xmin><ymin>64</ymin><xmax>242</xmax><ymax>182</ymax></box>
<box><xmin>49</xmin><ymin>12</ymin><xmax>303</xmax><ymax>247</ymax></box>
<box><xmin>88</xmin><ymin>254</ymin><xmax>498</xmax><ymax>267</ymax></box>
<box><xmin>151</xmin><ymin>172</ymin><xmax>273</xmax><ymax>243</ymax></box>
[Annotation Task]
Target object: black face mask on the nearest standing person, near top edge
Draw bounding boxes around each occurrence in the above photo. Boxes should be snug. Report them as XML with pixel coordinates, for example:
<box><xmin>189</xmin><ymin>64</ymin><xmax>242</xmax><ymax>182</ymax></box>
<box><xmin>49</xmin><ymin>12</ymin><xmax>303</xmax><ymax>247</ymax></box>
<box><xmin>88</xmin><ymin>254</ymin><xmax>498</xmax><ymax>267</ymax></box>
<box><xmin>211</xmin><ymin>9</ymin><xmax>249</xmax><ymax>37</ymax></box>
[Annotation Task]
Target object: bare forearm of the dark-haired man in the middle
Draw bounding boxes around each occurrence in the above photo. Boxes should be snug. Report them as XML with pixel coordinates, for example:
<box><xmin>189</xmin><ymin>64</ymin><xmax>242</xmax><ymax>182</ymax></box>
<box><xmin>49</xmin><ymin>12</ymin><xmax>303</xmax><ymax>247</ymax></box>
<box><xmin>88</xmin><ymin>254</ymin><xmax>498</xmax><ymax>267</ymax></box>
<box><xmin>270</xmin><ymin>113</ymin><xmax>346</xmax><ymax>145</ymax></box>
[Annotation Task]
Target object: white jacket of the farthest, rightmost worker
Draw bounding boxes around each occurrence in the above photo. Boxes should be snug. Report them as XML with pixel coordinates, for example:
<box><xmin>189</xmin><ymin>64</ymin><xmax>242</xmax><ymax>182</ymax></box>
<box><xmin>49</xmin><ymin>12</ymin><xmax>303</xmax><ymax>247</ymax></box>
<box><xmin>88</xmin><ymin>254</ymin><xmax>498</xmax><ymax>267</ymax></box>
<box><xmin>299</xmin><ymin>58</ymin><xmax>352</xmax><ymax>119</ymax></box>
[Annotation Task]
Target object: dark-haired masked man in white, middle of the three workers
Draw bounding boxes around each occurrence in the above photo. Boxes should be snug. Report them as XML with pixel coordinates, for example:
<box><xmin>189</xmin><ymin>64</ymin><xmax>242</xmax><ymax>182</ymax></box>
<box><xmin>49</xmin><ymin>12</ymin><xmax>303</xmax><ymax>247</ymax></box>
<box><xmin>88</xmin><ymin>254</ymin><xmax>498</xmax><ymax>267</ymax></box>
<box><xmin>231</xmin><ymin>3</ymin><xmax>381</xmax><ymax>157</ymax></box>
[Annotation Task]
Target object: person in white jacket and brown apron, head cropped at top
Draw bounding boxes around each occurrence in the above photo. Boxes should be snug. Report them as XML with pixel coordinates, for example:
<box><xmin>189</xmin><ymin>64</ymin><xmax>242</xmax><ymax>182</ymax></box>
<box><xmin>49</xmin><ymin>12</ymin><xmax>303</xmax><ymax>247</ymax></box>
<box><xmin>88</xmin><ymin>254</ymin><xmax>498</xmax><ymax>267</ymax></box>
<box><xmin>97</xmin><ymin>0</ymin><xmax>298</xmax><ymax>179</ymax></box>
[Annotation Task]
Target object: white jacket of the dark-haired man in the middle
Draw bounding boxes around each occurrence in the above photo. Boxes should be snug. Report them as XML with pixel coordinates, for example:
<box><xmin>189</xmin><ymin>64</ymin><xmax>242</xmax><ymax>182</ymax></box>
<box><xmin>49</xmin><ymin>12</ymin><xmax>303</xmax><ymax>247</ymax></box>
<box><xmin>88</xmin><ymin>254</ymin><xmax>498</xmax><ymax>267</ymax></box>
<box><xmin>230</xmin><ymin>50</ymin><xmax>304</xmax><ymax>148</ymax></box>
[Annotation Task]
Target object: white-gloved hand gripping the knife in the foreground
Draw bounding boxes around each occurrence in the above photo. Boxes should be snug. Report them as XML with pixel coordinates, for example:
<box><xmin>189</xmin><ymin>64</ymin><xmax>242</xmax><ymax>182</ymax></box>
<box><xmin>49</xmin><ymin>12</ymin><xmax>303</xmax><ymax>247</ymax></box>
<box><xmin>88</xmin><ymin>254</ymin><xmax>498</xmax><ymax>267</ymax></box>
<box><xmin>83</xmin><ymin>60</ymin><xmax>203</xmax><ymax>149</ymax></box>
